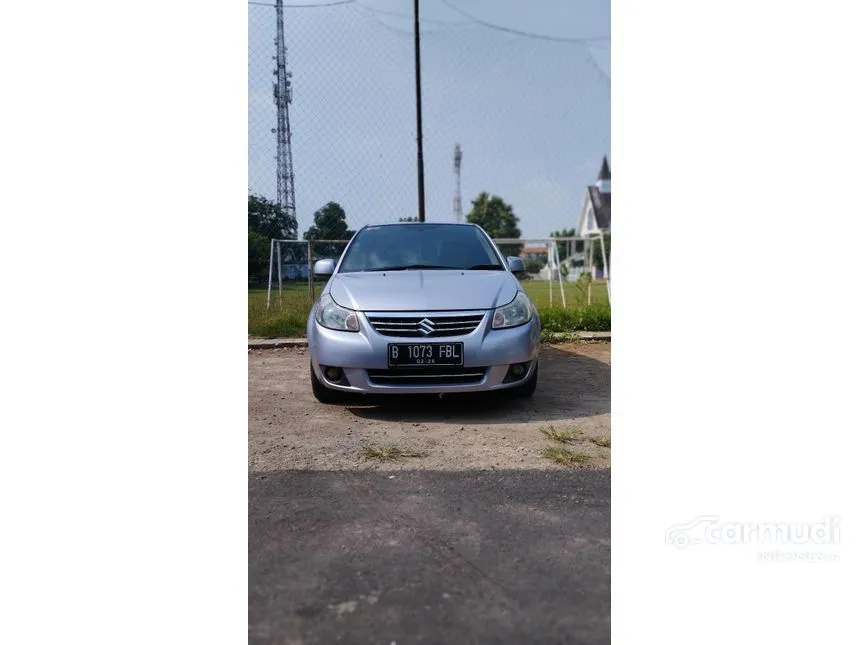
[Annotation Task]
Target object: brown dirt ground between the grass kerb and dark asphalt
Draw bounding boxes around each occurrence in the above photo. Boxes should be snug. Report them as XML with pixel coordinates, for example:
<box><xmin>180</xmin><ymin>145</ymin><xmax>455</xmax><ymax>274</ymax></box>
<box><xmin>248</xmin><ymin>343</ymin><xmax>611</xmax><ymax>473</ymax></box>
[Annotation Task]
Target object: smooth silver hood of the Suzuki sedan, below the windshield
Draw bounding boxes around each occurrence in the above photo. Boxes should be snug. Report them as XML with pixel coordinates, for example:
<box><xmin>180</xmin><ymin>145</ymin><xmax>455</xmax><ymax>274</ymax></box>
<box><xmin>329</xmin><ymin>270</ymin><xmax>518</xmax><ymax>311</ymax></box>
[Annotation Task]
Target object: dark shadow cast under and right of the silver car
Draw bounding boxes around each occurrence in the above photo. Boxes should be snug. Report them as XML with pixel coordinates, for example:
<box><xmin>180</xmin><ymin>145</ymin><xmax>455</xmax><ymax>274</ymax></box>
<box><xmin>346</xmin><ymin>346</ymin><xmax>611</xmax><ymax>423</ymax></box>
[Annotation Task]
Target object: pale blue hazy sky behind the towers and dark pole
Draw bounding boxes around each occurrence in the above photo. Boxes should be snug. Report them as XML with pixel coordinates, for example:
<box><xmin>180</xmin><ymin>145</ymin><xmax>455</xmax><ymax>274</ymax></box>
<box><xmin>249</xmin><ymin>0</ymin><xmax>610</xmax><ymax>237</ymax></box>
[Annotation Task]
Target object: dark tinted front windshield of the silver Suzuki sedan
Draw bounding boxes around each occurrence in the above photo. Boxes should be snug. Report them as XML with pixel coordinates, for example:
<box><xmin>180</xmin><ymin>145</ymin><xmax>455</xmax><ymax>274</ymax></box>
<box><xmin>339</xmin><ymin>224</ymin><xmax>505</xmax><ymax>273</ymax></box>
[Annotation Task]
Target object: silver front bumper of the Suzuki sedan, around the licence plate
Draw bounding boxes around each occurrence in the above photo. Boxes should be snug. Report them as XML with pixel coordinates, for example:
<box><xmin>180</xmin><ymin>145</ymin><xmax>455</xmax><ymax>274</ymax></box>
<box><xmin>308</xmin><ymin>311</ymin><xmax>540</xmax><ymax>394</ymax></box>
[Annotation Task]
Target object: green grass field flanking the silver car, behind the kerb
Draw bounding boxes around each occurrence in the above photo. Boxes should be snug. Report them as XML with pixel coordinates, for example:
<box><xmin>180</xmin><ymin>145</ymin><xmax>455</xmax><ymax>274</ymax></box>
<box><xmin>248</xmin><ymin>280</ymin><xmax>612</xmax><ymax>338</ymax></box>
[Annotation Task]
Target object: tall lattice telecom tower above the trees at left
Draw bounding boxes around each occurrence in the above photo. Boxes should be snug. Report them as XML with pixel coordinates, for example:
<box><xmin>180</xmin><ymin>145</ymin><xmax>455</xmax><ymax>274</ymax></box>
<box><xmin>272</xmin><ymin>0</ymin><xmax>296</xmax><ymax>236</ymax></box>
